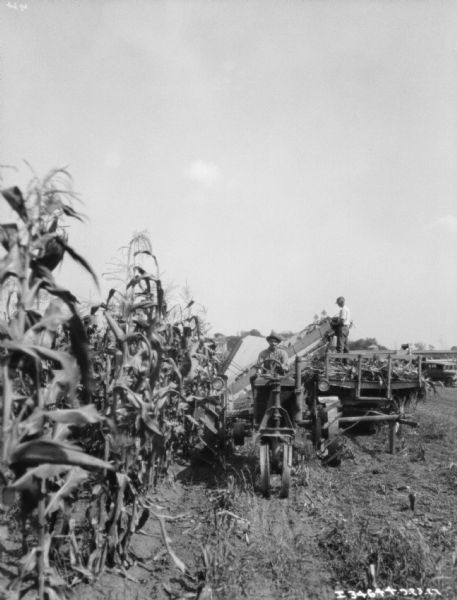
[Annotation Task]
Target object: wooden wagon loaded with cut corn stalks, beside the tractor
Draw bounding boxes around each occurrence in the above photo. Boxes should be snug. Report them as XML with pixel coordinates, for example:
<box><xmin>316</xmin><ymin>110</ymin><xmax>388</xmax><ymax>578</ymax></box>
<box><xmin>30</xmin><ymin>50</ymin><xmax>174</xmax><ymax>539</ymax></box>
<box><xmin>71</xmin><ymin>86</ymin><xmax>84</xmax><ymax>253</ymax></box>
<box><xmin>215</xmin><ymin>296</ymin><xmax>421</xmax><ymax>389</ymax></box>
<box><xmin>297</xmin><ymin>352</ymin><xmax>425</xmax><ymax>464</ymax></box>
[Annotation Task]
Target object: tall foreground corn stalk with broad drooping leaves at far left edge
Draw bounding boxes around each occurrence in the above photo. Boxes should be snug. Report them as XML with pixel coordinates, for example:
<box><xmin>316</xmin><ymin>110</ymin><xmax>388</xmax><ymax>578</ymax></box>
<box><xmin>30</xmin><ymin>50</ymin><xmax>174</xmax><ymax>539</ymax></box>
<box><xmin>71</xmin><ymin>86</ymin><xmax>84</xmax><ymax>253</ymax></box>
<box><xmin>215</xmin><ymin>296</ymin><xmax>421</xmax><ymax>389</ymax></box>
<box><xmin>0</xmin><ymin>170</ymin><xmax>113</xmax><ymax>600</ymax></box>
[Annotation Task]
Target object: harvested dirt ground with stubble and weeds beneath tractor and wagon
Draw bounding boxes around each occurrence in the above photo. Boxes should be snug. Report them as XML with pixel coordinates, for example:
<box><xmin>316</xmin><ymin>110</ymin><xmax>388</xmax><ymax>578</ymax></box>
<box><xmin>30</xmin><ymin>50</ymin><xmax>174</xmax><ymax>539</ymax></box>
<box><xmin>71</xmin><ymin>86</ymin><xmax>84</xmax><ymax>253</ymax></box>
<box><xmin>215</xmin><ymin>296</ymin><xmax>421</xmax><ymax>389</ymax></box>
<box><xmin>2</xmin><ymin>389</ymin><xmax>457</xmax><ymax>600</ymax></box>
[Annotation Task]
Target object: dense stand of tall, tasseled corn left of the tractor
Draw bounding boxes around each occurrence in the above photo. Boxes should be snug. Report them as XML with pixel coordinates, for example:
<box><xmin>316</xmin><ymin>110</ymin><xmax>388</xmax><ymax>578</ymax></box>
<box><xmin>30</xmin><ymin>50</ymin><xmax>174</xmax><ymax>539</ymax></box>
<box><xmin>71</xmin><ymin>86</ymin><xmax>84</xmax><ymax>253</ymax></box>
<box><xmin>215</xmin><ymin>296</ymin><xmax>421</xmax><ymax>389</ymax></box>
<box><xmin>0</xmin><ymin>170</ymin><xmax>223</xmax><ymax>600</ymax></box>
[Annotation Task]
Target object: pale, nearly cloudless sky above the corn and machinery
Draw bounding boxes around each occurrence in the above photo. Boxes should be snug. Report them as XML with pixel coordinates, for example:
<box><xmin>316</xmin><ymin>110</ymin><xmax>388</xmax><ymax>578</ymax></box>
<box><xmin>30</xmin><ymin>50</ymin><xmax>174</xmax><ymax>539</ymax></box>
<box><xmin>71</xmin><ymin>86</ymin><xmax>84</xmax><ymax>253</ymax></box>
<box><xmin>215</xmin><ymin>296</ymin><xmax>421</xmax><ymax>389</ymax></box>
<box><xmin>0</xmin><ymin>0</ymin><xmax>457</xmax><ymax>348</ymax></box>
